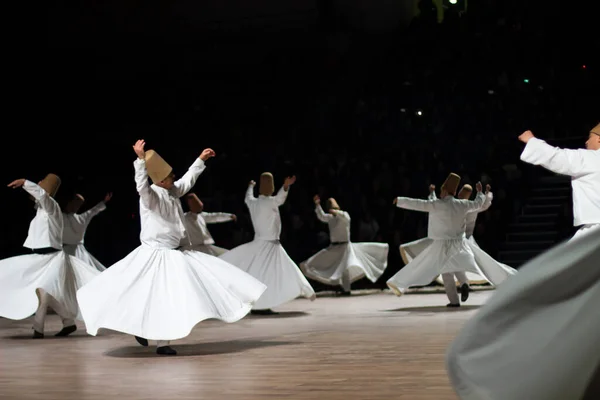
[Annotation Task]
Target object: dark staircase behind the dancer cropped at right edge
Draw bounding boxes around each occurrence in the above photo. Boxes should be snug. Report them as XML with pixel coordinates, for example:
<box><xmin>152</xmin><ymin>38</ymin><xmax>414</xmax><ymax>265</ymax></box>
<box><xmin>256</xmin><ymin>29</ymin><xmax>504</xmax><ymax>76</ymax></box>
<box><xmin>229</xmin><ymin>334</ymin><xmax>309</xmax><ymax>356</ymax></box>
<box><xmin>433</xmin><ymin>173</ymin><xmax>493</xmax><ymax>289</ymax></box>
<box><xmin>498</xmin><ymin>175</ymin><xmax>571</xmax><ymax>268</ymax></box>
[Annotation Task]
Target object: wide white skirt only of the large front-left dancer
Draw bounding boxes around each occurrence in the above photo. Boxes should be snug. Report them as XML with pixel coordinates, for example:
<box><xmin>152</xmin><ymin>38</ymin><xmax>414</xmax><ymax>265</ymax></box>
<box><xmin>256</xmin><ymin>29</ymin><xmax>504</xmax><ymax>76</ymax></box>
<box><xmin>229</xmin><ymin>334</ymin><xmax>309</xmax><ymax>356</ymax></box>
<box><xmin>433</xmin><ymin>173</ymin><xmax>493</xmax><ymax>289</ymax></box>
<box><xmin>77</xmin><ymin>245</ymin><xmax>266</xmax><ymax>340</ymax></box>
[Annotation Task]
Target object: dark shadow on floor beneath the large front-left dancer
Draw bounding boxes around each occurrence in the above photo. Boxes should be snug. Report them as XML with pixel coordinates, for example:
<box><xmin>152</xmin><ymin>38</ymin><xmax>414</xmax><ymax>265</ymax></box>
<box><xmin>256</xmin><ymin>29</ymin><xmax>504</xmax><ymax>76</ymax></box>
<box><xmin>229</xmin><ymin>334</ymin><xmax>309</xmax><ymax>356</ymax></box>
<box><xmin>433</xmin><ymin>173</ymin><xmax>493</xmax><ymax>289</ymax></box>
<box><xmin>104</xmin><ymin>340</ymin><xmax>302</xmax><ymax>358</ymax></box>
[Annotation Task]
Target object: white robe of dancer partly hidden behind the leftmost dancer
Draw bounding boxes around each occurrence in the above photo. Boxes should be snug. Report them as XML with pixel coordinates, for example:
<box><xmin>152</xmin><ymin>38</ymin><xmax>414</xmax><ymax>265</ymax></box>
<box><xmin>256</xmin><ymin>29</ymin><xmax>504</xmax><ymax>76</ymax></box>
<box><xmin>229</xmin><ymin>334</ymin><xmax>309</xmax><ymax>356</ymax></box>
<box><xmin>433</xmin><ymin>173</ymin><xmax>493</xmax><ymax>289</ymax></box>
<box><xmin>63</xmin><ymin>201</ymin><xmax>106</xmax><ymax>272</ymax></box>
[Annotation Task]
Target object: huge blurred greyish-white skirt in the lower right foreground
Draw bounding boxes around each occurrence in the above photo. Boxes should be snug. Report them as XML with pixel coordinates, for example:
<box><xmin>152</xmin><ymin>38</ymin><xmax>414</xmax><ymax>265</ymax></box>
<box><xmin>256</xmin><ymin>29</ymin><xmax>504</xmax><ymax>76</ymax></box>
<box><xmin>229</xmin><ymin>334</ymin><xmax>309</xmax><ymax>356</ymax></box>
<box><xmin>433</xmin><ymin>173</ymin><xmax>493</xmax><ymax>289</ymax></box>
<box><xmin>447</xmin><ymin>230</ymin><xmax>600</xmax><ymax>400</ymax></box>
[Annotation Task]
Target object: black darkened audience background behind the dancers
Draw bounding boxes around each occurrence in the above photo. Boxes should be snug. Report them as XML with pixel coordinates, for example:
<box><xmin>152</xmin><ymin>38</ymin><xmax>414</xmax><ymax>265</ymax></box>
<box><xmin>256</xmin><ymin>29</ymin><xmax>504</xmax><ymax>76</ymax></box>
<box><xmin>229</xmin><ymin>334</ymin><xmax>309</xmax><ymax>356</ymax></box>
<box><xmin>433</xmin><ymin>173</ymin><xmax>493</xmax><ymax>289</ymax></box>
<box><xmin>0</xmin><ymin>0</ymin><xmax>600</xmax><ymax>287</ymax></box>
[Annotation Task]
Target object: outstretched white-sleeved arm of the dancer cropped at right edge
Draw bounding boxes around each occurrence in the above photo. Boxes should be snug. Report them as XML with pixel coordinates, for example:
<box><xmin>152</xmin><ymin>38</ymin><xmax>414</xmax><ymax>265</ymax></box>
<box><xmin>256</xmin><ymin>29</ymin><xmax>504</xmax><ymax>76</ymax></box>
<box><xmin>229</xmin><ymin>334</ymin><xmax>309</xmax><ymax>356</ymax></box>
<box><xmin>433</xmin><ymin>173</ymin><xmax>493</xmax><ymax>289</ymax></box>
<box><xmin>519</xmin><ymin>131</ymin><xmax>600</xmax><ymax>177</ymax></box>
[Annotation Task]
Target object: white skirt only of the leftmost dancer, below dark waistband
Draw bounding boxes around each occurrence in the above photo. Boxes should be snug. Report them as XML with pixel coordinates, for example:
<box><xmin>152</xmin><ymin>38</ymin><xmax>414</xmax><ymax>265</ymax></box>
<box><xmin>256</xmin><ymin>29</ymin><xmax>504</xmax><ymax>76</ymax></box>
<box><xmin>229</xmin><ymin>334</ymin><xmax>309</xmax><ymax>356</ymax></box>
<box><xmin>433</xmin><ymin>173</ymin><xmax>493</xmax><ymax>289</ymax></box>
<box><xmin>0</xmin><ymin>251</ymin><xmax>100</xmax><ymax>320</ymax></box>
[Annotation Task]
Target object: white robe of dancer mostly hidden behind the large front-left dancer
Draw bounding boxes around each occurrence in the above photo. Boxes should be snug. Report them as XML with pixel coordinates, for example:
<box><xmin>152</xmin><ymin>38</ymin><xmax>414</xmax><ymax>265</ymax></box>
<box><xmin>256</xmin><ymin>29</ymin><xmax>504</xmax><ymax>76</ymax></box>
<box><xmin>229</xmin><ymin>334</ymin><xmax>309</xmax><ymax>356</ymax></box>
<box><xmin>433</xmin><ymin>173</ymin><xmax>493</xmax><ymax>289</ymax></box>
<box><xmin>181</xmin><ymin>211</ymin><xmax>233</xmax><ymax>257</ymax></box>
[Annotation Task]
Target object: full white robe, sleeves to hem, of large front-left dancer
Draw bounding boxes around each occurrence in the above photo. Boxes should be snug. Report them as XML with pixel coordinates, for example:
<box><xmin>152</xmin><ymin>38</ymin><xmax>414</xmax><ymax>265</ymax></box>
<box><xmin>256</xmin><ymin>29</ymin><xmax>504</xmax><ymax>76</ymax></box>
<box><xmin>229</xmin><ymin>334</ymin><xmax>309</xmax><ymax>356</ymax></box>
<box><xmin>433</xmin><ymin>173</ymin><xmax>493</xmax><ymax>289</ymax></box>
<box><xmin>77</xmin><ymin>159</ymin><xmax>266</xmax><ymax>341</ymax></box>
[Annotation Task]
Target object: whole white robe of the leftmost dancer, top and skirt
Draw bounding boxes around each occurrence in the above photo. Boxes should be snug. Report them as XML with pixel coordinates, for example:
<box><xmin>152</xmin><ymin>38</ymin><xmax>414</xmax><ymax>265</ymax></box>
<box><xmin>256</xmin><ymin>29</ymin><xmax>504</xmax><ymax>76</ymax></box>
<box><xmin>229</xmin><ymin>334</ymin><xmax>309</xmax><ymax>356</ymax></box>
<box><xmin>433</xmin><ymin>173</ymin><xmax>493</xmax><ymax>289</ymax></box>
<box><xmin>0</xmin><ymin>181</ymin><xmax>100</xmax><ymax>320</ymax></box>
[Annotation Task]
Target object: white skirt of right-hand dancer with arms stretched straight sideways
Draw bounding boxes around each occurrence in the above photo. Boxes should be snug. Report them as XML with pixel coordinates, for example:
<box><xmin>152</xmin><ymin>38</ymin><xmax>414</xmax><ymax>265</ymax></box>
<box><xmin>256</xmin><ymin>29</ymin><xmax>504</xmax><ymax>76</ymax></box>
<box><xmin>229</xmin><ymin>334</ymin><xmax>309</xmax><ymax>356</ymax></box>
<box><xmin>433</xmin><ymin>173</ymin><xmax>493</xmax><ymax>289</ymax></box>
<box><xmin>387</xmin><ymin>239</ymin><xmax>493</xmax><ymax>296</ymax></box>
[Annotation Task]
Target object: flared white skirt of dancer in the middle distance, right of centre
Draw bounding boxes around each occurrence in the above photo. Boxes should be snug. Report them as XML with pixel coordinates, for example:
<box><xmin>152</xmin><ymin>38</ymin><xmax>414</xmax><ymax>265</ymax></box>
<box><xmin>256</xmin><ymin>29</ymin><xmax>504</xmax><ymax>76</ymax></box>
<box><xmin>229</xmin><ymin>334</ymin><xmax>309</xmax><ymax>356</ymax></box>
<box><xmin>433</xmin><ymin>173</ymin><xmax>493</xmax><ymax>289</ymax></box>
<box><xmin>300</xmin><ymin>243</ymin><xmax>389</xmax><ymax>285</ymax></box>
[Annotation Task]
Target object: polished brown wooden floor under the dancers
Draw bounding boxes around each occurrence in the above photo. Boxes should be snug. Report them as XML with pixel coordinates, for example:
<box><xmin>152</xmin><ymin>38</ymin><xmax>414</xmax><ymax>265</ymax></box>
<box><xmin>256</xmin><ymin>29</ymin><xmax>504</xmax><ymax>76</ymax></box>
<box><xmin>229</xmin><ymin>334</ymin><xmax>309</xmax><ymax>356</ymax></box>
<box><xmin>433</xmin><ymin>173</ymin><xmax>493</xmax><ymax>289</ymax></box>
<box><xmin>0</xmin><ymin>291</ymin><xmax>491</xmax><ymax>400</ymax></box>
